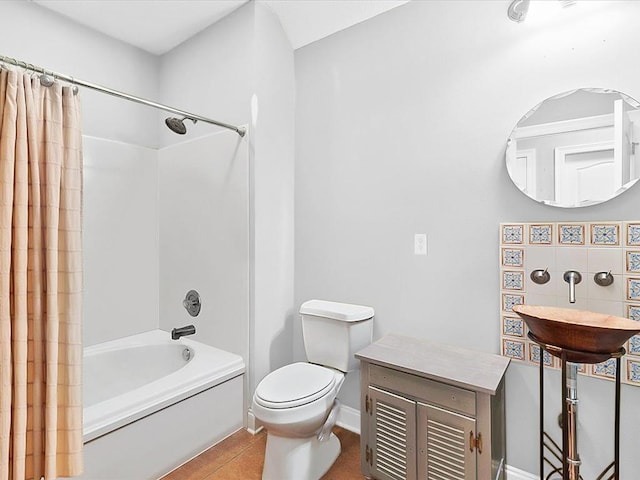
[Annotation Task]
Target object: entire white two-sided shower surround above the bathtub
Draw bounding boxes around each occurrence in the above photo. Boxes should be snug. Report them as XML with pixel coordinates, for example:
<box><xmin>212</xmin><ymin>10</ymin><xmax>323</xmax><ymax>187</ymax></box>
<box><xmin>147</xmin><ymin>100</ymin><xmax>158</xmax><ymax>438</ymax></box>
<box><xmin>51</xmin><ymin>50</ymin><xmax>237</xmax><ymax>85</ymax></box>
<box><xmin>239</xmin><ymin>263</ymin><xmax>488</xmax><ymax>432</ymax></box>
<box><xmin>83</xmin><ymin>131</ymin><xmax>249</xmax><ymax>355</ymax></box>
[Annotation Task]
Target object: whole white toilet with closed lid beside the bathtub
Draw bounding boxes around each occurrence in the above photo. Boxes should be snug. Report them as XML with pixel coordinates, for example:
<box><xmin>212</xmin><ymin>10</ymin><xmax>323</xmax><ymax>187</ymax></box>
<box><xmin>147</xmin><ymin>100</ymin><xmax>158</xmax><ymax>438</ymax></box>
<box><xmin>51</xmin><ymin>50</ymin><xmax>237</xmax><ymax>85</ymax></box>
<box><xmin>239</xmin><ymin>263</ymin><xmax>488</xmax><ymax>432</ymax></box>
<box><xmin>252</xmin><ymin>300</ymin><xmax>374</xmax><ymax>480</ymax></box>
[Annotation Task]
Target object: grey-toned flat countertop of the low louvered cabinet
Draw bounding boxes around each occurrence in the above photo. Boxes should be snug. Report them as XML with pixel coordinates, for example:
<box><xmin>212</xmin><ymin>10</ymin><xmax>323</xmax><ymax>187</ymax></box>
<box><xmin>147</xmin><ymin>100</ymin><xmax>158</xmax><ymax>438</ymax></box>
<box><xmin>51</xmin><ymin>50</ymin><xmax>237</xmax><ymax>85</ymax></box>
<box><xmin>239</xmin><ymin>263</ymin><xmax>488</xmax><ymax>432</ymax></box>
<box><xmin>356</xmin><ymin>334</ymin><xmax>509</xmax><ymax>395</ymax></box>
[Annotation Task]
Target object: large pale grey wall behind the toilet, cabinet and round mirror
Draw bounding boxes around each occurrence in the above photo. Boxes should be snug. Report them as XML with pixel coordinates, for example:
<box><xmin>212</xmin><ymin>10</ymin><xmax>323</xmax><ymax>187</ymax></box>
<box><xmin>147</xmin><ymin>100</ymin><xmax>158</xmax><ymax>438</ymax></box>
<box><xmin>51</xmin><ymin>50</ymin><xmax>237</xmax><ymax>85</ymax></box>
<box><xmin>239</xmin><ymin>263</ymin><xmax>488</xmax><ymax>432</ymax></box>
<box><xmin>294</xmin><ymin>1</ymin><xmax>640</xmax><ymax>478</ymax></box>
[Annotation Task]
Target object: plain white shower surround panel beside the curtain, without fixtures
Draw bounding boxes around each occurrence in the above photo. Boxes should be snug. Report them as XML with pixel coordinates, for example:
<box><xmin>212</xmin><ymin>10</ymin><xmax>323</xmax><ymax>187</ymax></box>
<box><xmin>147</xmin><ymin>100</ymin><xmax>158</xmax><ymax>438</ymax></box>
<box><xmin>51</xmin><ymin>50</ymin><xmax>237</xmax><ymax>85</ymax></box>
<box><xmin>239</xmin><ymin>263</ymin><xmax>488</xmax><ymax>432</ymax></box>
<box><xmin>82</xmin><ymin>135</ymin><xmax>159</xmax><ymax>346</ymax></box>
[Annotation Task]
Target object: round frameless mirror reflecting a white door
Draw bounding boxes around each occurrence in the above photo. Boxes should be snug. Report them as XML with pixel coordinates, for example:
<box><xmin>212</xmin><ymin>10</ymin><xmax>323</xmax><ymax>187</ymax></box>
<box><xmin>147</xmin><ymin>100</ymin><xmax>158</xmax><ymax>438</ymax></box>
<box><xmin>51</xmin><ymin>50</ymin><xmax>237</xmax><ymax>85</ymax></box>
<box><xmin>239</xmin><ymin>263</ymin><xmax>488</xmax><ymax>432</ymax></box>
<box><xmin>506</xmin><ymin>88</ymin><xmax>640</xmax><ymax>208</ymax></box>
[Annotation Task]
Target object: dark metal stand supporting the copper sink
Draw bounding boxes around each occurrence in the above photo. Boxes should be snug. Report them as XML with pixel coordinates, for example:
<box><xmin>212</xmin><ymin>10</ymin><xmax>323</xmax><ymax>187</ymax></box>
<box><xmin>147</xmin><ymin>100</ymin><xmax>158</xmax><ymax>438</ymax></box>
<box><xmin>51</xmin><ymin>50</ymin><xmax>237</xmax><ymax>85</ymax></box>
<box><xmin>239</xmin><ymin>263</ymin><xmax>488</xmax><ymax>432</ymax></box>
<box><xmin>528</xmin><ymin>332</ymin><xmax>626</xmax><ymax>480</ymax></box>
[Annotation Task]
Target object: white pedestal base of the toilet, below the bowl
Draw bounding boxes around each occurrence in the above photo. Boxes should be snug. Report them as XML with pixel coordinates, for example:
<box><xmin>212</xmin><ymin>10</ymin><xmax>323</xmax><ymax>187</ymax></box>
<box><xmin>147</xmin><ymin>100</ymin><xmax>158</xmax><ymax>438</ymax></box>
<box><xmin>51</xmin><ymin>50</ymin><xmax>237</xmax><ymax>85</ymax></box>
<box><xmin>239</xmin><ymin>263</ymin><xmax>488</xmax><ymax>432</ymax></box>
<box><xmin>262</xmin><ymin>433</ymin><xmax>340</xmax><ymax>480</ymax></box>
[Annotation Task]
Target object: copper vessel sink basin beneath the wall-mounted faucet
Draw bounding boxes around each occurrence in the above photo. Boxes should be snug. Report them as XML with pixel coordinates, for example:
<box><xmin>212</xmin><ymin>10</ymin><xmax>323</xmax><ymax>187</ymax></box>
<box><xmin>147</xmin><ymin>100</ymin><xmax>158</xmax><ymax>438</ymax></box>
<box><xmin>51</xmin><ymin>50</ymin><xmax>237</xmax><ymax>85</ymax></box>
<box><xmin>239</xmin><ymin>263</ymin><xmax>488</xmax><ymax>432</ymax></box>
<box><xmin>513</xmin><ymin>305</ymin><xmax>640</xmax><ymax>354</ymax></box>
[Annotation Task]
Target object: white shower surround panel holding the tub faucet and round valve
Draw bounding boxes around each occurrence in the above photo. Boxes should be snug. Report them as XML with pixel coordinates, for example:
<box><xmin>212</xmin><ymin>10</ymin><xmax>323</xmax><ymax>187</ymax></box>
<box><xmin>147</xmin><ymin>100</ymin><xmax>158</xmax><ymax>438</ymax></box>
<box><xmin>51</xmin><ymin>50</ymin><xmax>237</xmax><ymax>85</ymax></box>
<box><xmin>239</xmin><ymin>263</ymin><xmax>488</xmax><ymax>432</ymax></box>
<box><xmin>158</xmin><ymin>131</ymin><xmax>249</xmax><ymax>356</ymax></box>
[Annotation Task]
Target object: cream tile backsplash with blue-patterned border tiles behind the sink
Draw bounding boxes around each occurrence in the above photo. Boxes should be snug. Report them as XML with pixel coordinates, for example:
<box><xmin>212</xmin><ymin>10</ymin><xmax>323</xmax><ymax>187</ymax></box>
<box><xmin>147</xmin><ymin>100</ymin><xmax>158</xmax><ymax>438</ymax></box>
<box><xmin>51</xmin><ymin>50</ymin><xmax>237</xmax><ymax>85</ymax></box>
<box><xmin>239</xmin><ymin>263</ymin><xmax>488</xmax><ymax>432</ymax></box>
<box><xmin>499</xmin><ymin>221</ymin><xmax>640</xmax><ymax>386</ymax></box>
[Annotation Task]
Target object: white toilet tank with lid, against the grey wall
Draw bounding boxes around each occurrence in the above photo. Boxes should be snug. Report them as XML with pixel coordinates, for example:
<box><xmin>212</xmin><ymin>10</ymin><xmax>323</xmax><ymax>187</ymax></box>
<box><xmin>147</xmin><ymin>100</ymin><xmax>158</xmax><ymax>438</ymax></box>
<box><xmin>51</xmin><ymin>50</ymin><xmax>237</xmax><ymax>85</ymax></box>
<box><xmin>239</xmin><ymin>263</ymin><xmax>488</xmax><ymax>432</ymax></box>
<box><xmin>300</xmin><ymin>300</ymin><xmax>374</xmax><ymax>372</ymax></box>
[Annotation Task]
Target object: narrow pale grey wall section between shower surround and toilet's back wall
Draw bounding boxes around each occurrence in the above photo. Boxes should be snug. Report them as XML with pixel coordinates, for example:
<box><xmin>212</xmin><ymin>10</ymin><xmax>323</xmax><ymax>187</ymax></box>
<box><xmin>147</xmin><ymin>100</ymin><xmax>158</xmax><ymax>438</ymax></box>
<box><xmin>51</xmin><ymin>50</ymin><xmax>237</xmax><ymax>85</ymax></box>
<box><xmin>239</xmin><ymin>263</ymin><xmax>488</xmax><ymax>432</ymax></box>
<box><xmin>250</xmin><ymin>3</ymin><xmax>296</xmax><ymax>402</ymax></box>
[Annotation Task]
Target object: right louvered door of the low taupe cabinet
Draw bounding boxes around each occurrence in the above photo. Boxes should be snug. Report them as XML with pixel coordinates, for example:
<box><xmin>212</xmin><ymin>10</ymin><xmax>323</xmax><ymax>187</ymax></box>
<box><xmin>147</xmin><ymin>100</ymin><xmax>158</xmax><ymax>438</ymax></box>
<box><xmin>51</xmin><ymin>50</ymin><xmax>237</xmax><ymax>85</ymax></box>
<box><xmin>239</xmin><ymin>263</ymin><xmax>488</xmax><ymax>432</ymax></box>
<box><xmin>417</xmin><ymin>403</ymin><xmax>481</xmax><ymax>480</ymax></box>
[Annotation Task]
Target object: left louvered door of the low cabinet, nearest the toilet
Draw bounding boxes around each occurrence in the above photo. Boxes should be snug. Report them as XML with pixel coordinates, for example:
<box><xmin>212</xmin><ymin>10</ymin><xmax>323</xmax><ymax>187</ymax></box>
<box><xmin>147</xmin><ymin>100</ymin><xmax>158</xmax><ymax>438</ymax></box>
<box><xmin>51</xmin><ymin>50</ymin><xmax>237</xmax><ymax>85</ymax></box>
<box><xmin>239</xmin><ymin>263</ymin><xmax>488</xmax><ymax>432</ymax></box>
<box><xmin>365</xmin><ymin>387</ymin><xmax>416</xmax><ymax>480</ymax></box>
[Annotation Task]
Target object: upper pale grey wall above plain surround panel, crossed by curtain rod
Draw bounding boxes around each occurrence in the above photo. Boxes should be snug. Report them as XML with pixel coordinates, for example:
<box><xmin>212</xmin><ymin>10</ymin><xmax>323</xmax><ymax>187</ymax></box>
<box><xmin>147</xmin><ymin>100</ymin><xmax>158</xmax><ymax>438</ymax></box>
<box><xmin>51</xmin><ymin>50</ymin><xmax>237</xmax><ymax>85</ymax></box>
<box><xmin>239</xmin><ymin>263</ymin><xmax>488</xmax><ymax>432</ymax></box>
<box><xmin>0</xmin><ymin>0</ymin><xmax>158</xmax><ymax>147</ymax></box>
